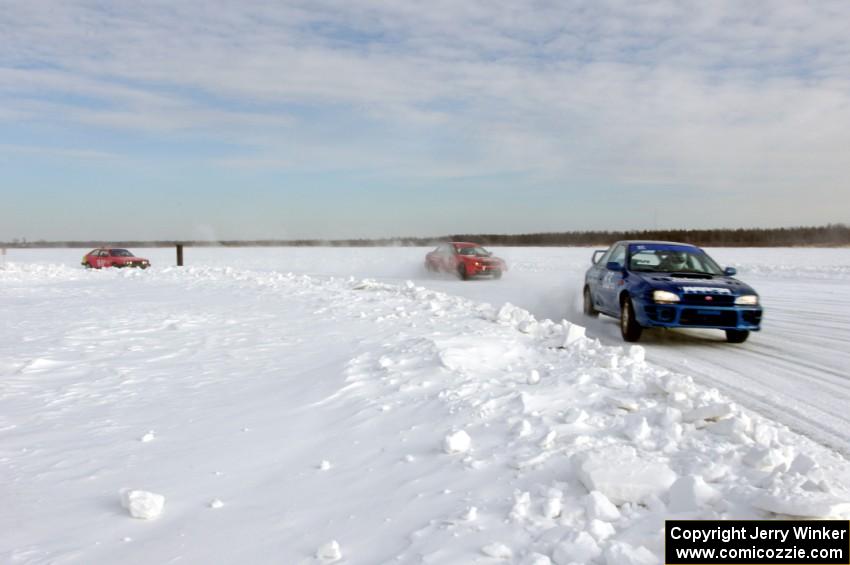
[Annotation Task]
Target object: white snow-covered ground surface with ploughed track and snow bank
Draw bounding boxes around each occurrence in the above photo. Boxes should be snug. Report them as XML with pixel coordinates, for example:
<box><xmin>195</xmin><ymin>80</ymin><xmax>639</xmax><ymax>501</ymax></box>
<box><xmin>0</xmin><ymin>248</ymin><xmax>850</xmax><ymax>565</ymax></box>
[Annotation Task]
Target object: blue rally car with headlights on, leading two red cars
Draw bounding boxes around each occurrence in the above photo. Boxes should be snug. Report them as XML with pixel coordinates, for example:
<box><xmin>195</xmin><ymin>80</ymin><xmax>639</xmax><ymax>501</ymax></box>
<box><xmin>584</xmin><ymin>241</ymin><xmax>762</xmax><ymax>343</ymax></box>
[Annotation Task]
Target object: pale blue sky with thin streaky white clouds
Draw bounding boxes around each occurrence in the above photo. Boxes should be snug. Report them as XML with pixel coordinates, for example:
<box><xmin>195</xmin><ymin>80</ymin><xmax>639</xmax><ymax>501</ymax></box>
<box><xmin>0</xmin><ymin>0</ymin><xmax>850</xmax><ymax>241</ymax></box>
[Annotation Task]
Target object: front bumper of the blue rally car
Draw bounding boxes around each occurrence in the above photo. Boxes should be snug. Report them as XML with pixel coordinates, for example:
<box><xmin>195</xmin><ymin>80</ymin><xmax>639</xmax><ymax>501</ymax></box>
<box><xmin>635</xmin><ymin>302</ymin><xmax>762</xmax><ymax>331</ymax></box>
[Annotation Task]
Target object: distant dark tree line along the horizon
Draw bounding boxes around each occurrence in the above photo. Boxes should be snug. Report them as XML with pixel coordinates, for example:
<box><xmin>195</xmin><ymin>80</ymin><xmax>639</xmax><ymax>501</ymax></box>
<box><xmin>6</xmin><ymin>224</ymin><xmax>850</xmax><ymax>248</ymax></box>
